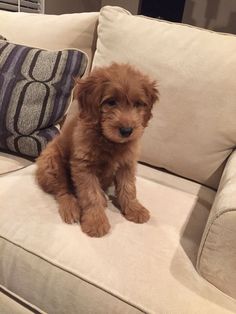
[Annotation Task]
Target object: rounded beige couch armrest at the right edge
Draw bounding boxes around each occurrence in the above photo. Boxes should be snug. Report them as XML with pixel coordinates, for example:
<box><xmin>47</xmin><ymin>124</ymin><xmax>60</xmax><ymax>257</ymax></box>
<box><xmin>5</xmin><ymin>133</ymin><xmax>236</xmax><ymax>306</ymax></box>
<box><xmin>197</xmin><ymin>150</ymin><xmax>236</xmax><ymax>298</ymax></box>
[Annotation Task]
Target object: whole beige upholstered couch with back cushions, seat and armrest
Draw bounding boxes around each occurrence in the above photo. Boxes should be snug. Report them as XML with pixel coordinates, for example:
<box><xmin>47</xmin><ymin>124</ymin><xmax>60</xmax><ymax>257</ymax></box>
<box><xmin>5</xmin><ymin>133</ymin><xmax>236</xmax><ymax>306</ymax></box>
<box><xmin>0</xmin><ymin>7</ymin><xmax>236</xmax><ymax>314</ymax></box>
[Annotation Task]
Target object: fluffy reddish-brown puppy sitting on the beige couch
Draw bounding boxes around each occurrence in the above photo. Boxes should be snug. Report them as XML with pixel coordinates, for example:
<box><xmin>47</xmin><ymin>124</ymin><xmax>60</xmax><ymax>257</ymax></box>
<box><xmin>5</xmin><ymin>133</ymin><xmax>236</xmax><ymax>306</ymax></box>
<box><xmin>36</xmin><ymin>63</ymin><xmax>158</xmax><ymax>237</ymax></box>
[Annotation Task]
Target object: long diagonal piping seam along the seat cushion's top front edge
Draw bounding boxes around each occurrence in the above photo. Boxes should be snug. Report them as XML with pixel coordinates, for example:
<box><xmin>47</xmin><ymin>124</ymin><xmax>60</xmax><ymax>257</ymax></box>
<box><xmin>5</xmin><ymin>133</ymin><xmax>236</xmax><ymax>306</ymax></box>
<box><xmin>0</xmin><ymin>235</ymin><xmax>147</xmax><ymax>314</ymax></box>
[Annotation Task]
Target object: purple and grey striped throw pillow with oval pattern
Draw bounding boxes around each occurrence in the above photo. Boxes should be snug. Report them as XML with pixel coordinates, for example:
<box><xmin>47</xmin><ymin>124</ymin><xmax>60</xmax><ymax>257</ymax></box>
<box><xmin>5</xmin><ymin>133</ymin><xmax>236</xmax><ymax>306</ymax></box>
<box><xmin>0</xmin><ymin>40</ymin><xmax>87</xmax><ymax>157</ymax></box>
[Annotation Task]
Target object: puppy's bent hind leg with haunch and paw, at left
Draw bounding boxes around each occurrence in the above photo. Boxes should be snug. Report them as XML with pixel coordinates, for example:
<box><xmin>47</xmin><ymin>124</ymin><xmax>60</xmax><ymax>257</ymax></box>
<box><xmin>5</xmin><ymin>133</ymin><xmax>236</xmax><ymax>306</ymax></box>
<box><xmin>36</xmin><ymin>140</ymin><xmax>80</xmax><ymax>224</ymax></box>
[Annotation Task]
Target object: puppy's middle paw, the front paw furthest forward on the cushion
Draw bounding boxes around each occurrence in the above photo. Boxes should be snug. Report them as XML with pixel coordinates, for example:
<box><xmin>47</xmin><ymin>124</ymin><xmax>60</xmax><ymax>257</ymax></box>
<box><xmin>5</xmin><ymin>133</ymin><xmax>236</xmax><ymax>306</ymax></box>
<box><xmin>81</xmin><ymin>210</ymin><xmax>110</xmax><ymax>237</ymax></box>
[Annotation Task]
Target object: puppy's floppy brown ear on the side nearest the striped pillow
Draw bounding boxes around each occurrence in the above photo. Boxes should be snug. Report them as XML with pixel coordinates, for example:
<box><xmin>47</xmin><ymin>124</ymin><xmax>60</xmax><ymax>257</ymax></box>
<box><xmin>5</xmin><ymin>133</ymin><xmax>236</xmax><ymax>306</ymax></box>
<box><xmin>77</xmin><ymin>74</ymin><xmax>102</xmax><ymax>123</ymax></box>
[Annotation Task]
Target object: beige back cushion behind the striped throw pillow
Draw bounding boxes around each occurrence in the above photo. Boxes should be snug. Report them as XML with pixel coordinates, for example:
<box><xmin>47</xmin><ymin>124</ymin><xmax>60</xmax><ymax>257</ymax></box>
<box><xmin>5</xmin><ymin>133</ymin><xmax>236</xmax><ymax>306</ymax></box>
<box><xmin>0</xmin><ymin>10</ymin><xmax>98</xmax><ymax>70</ymax></box>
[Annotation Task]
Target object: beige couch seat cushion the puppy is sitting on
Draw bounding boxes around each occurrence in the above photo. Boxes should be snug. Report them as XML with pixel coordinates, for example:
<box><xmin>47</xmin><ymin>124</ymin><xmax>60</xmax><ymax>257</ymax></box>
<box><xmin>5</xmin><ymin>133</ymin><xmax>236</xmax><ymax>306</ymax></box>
<box><xmin>0</xmin><ymin>165</ymin><xmax>236</xmax><ymax>314</ymax></box>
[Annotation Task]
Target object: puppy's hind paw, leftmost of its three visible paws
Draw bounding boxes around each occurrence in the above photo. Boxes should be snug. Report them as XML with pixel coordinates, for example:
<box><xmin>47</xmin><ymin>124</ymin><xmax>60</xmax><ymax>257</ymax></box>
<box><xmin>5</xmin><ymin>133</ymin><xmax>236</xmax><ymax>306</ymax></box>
<box><xmin>58</xmin><ymin>195</ymin><xmax>80</xmax><ymax>224</ymax></box>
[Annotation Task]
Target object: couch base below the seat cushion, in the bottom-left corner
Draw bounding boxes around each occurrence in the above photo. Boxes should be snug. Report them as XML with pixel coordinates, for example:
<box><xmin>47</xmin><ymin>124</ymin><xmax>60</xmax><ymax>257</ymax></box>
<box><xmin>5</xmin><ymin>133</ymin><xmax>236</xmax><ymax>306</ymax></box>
<box><xmin>0</xmin><ymin>285</ymin><xmax>45</xmax><ymax>314</ymax></box>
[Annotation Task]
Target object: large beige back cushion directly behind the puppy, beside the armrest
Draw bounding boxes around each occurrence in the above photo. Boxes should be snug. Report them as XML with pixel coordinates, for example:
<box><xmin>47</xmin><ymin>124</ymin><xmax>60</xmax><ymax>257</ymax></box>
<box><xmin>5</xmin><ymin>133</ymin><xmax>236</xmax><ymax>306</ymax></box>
<box><xmin>93</xmin><ymin>7</ymin><xmax>236</xmax><ymax>188</ymax></box>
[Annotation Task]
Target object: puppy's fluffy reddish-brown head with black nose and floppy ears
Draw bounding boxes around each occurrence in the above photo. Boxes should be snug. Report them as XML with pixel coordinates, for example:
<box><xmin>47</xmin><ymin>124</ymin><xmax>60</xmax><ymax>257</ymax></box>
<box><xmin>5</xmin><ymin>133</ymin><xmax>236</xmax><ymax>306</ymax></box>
<box><xmin>78</xmin><ymin>63</ymin><xmax>158</xmax><ymax>143</ymax></box>
